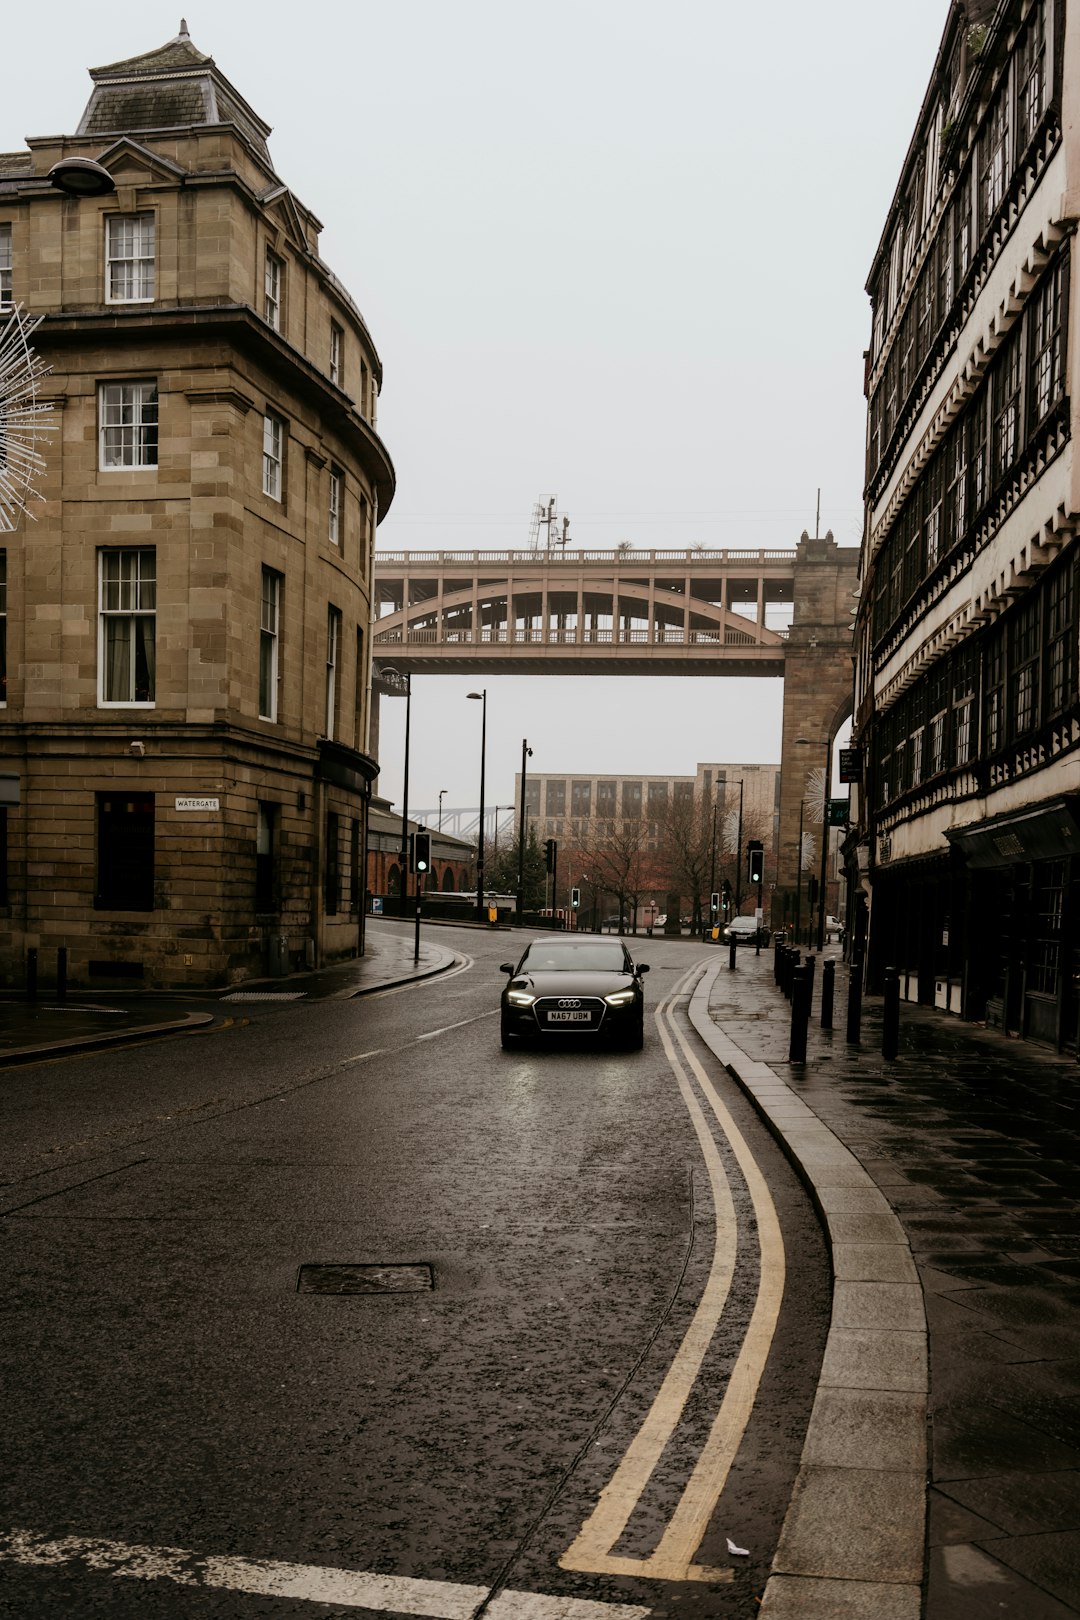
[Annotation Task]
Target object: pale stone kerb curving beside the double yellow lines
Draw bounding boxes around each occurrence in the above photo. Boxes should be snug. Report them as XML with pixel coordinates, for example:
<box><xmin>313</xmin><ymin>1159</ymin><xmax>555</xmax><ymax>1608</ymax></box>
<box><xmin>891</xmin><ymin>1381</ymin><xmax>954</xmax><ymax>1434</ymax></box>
<box><xmin>690</xmin><ymin>962</ymin><xmax>929</xmax><ymax>1620</ymax></box>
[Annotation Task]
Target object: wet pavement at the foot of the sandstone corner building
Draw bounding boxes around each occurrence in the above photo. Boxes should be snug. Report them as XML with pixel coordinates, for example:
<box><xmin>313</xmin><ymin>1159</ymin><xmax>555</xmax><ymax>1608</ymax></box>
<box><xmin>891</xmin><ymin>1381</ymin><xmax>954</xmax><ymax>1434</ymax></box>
<box><xmin>0</xmin><ymin>920</ymin><xmax>457</xmax><ymax>1068</ymax></box>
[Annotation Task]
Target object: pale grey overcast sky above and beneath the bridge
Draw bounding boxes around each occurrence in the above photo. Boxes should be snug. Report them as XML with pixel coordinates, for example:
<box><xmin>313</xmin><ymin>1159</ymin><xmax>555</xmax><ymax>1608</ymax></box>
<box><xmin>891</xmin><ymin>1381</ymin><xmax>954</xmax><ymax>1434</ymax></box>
<box><xmin>10</xmin><ymin>0</ymin><xmax>947</xmax><ymax>808</ymax></box>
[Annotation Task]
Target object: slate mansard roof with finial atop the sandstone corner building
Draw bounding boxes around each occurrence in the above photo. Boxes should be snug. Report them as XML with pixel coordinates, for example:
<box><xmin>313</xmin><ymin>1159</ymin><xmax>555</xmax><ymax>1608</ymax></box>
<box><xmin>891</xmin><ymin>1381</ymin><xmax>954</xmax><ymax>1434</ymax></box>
<box><xmin>78</xmin><ymin>19</ymin><xmax>270</xmax><ymax>165</ymax></box>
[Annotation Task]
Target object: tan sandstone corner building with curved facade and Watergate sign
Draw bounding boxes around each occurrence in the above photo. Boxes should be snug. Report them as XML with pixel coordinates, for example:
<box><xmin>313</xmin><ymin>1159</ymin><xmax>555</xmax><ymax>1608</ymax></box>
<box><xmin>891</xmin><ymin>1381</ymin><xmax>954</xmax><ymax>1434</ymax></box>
<box><xmin>0</xmin><ymin>31</ymin><xmax>393</xmax><ymax>987</ymax></box>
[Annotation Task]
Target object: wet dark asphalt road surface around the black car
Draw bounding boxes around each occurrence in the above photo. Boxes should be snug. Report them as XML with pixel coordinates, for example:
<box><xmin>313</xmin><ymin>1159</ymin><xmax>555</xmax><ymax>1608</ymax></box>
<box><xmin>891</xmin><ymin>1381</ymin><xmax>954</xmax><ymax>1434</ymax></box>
<box><xmin>0</xmin><ymin>930</ymin><xmax>829</xmax><ymax>1620</ymax></box>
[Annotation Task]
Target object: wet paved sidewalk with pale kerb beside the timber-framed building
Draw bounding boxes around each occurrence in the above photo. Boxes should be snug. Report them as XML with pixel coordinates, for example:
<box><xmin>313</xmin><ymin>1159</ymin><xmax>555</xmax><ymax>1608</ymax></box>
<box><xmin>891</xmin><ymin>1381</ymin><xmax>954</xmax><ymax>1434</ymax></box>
<box><xmin>691</xmin><ymin>949</ymin><xmax>1080</xmax><ymax>1620</ymax></box>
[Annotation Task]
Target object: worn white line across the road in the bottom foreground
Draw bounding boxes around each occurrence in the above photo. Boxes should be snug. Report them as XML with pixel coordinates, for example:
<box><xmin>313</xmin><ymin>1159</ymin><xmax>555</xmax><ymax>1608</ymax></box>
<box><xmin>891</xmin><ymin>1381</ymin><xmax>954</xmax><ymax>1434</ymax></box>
<box><xmin>0</xmin><ymin>1531</ymin><xmax>651</xmax><ymax>1620</ymax></box>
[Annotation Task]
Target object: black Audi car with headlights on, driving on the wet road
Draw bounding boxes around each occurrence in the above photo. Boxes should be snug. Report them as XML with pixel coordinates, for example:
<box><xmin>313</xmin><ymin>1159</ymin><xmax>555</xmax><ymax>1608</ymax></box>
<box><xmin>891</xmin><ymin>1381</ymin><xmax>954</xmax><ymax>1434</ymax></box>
<box><xmin>500</xmin><ymin>935</ymin><xmax>649</xmax><ymax>1051</ymax></box>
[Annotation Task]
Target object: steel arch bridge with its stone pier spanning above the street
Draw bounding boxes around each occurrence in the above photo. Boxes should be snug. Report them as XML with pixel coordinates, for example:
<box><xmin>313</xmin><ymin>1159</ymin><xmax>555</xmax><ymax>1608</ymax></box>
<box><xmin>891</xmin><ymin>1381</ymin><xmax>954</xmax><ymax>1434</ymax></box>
<box><xmin>372</xmin><ymin>533</ymin><xmax>860</xmax><ymax>891</ymax></box>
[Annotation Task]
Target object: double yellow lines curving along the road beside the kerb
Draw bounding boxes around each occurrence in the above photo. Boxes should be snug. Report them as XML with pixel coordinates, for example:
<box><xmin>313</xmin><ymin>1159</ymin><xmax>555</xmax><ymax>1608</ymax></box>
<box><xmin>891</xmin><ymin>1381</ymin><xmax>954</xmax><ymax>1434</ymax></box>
<box><xmin>559</xmin><ymin>969</ymin><xmax>784</xmax><ymax>1581</ymax></box>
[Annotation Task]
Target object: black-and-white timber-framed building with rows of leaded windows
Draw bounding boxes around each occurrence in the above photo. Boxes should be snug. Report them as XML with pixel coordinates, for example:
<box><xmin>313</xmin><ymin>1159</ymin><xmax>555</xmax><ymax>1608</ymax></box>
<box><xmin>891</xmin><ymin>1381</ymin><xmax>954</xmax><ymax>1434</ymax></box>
<box><xmin>850</xmin><ymin>0</ymin><xmax>1080</xmax><ymax>1047</ymax></box>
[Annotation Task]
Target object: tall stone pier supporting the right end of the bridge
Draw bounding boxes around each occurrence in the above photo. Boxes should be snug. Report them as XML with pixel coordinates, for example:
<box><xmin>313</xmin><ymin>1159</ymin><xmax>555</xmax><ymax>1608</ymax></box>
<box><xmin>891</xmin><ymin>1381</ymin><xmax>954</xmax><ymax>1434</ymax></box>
<box><xmin>772</xmin><ymin>533</ymin><xmax>860</xmax><ymax>928</ymax></box>
